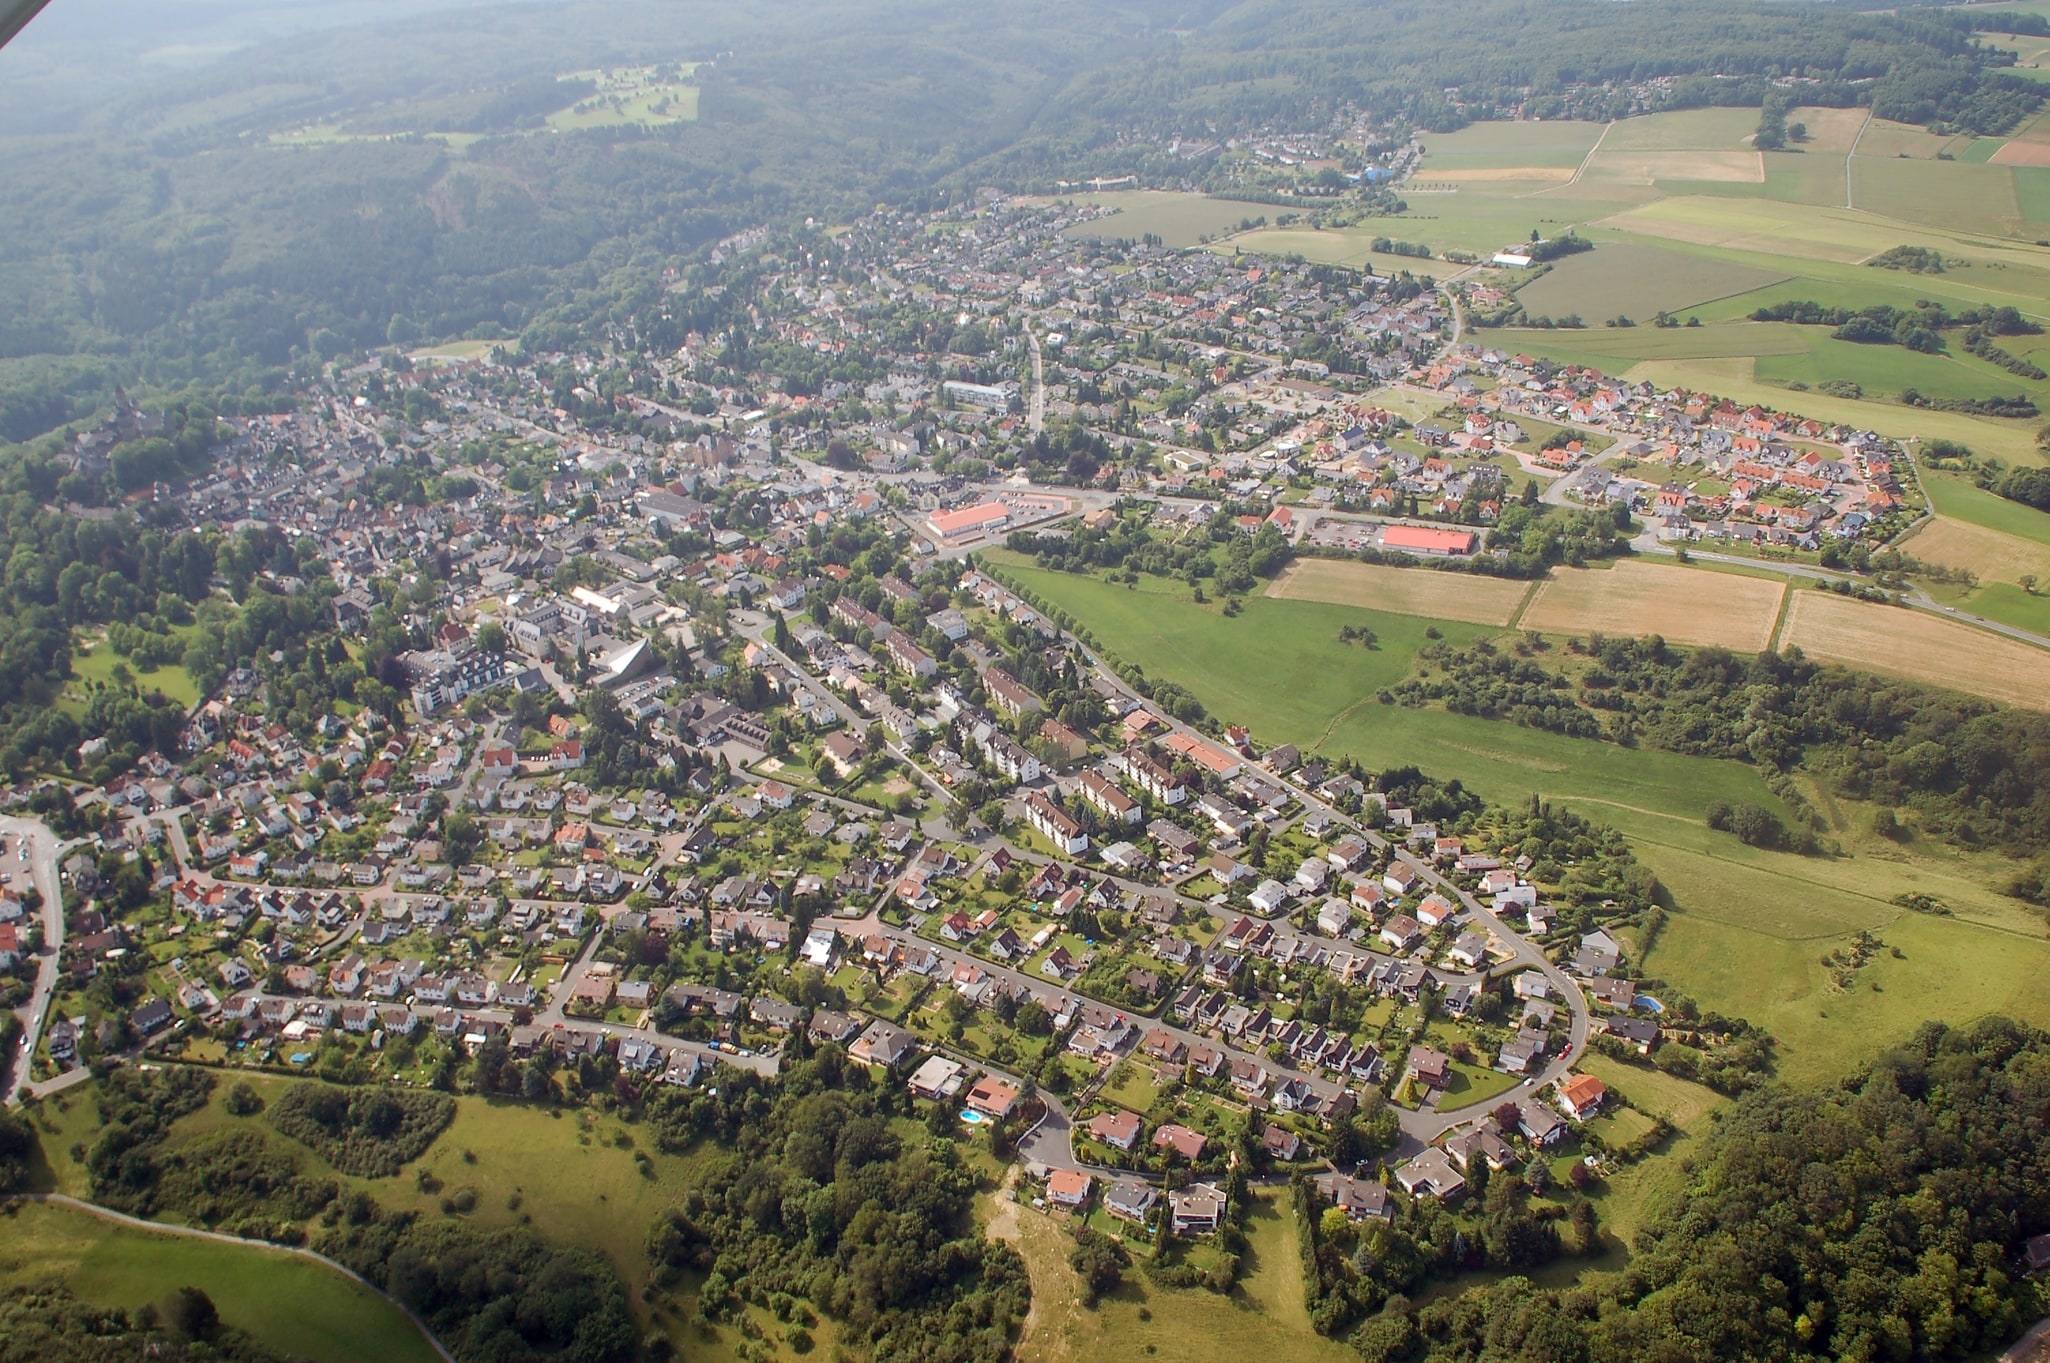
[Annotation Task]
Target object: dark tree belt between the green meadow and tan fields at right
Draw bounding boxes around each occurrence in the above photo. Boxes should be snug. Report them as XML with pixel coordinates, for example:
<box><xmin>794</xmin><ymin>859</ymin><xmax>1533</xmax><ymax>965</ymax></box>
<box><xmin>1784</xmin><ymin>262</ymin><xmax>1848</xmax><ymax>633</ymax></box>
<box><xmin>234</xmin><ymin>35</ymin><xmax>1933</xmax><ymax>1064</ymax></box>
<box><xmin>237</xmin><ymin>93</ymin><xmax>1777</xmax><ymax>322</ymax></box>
<box><xmin>1396</xmin><ymin>635</ymin><xmax>2050</xmax><ymax>855</ymax></box>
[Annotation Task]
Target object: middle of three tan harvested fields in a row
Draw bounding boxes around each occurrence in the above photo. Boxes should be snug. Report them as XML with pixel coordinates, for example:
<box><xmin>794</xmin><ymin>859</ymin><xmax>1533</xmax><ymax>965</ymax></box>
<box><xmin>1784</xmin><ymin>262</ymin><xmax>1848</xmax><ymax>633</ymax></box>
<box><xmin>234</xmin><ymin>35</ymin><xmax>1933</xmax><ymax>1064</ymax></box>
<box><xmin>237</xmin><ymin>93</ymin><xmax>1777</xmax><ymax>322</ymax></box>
<box><xmin>1521</xmin><ymin>560</ymin><xmax>1786</xmax><ymax>654</ymax></box>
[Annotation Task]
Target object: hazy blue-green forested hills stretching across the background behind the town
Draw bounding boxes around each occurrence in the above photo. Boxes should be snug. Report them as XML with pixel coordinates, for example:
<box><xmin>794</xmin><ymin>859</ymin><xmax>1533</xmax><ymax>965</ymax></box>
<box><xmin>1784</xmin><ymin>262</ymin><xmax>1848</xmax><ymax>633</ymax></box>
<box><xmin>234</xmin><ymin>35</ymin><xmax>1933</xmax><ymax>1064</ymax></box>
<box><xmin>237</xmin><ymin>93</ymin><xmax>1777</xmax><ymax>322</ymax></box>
<box><xmin>0</xmin><ymin>0</ymin><xmax>2040</xmax><ymax>441</ymax></box>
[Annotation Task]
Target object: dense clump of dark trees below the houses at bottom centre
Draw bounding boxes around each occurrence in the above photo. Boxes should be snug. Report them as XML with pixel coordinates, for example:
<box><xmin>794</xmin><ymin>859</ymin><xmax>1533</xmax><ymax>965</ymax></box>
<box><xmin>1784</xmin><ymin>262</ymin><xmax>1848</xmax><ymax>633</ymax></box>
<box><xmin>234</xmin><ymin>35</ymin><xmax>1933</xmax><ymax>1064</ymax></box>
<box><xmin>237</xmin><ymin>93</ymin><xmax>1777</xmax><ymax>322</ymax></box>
<box><xmin>648</xmin><ymin>1033</ymin><xmax>1029</xmax><ymax>1363</ymax></box>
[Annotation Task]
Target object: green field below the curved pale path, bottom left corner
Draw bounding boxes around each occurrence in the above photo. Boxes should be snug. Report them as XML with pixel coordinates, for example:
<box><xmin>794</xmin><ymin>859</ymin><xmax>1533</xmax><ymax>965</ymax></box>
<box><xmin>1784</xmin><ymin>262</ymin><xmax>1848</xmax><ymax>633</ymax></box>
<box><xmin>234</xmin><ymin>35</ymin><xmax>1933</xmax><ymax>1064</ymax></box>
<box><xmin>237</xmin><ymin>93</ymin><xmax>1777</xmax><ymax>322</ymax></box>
<box><xmin>0</xmin><ymin>1203</ymin><xmax>437</xmax><ymax>1363</ymax></box>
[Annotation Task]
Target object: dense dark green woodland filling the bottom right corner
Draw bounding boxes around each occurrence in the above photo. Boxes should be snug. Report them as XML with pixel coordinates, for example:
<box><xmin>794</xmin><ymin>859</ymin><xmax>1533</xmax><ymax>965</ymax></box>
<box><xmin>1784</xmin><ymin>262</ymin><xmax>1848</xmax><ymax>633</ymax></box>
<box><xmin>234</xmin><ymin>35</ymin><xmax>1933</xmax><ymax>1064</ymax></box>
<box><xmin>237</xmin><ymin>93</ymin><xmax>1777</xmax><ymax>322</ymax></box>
<box><xmin>1353</xmin><ymin>1019</ymin><xmax>2050</xmax><ymax>1363</ymax></box>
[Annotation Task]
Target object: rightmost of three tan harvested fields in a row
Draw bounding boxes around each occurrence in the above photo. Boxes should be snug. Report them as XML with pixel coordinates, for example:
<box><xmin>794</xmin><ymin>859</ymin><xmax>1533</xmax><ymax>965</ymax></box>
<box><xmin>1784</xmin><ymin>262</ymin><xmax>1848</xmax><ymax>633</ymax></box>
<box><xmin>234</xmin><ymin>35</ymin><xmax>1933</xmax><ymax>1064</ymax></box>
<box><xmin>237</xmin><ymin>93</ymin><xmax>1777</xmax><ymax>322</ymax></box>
<box><xmin>1779</xmin><ymin>590</ymin><xmax>2050</xmax><ymax>709</ymax></box>
